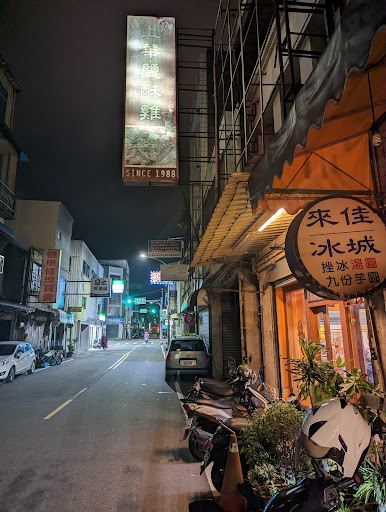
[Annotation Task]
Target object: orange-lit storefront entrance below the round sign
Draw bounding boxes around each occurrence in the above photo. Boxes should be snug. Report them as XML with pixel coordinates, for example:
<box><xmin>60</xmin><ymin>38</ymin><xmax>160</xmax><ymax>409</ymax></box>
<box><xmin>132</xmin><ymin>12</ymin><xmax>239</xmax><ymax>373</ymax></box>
<box><xmin>276</xmin><ymin>283</ymin><xmax>373</xmax><ymax>397</ymax></box>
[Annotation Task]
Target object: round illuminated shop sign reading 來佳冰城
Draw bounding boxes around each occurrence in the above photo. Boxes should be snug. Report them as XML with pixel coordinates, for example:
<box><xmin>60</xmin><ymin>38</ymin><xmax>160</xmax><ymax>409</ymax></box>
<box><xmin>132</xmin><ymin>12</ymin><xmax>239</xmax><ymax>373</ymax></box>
<box><xmin>285</xmin><ymin>196</ymin><xmax>386</xmax><ymax>300</ymax></box>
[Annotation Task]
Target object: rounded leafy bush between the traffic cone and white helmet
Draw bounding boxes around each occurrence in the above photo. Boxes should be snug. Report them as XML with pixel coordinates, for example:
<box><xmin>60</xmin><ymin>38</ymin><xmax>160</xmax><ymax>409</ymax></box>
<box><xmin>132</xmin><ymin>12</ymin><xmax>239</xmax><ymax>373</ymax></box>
<box><xmin>241</xmin><ymin>401</ymin><xmax>304</xmax><ymax>494</ymax></box>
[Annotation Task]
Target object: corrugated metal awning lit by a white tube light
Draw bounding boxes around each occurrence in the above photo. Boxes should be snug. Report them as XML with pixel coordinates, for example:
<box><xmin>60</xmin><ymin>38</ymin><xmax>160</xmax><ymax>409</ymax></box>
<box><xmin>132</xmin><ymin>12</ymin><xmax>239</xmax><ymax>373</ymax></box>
<box><xmin>191</xmin><ymin>172</ymin><xmax>293</xmax><ymax>267</ymax></box>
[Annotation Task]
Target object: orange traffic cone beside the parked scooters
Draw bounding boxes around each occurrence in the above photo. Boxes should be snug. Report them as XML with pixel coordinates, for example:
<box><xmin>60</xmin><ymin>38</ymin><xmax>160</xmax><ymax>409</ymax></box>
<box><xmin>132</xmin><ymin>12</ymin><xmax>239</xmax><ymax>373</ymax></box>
<box><xmin>219</xmin><ymin>434</ymin><xmax>247</xmax><ymax>512</ymax></box>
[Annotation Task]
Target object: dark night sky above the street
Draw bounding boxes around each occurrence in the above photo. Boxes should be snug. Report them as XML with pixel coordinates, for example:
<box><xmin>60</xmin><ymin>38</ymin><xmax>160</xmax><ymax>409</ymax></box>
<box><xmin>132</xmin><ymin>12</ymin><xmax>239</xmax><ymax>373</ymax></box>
<box><xmin>0</xmin><ymin>0</ymin><xmax>218</xmax><ymax>292</ymax></box>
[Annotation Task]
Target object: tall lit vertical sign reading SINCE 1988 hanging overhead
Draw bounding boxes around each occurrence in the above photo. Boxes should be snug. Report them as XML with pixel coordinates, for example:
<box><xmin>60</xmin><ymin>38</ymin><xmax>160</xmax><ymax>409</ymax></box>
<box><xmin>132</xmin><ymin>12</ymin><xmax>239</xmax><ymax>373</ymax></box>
<box><xmin>122</xmin><ymin>16</ymin><xmax>178</xmax><ymax>185</ymax></box>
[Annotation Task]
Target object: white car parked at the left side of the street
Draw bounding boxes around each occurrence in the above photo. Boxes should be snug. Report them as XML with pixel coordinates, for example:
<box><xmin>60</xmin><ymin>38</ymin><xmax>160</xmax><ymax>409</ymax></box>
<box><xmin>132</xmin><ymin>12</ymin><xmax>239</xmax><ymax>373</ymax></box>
<box><xmin>0</xmin><ymin>341</ymin><xmax>36</xmax><ymax>382</ymax></box>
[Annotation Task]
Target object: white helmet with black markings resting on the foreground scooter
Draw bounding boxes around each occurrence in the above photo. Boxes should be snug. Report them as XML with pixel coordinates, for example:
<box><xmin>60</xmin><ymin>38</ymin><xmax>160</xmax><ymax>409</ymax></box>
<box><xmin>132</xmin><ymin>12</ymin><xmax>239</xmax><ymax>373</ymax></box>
<box><xmin>301</xmin><ymin>398</ymin><xmax>371</xmax><ymax>478</ymax></box>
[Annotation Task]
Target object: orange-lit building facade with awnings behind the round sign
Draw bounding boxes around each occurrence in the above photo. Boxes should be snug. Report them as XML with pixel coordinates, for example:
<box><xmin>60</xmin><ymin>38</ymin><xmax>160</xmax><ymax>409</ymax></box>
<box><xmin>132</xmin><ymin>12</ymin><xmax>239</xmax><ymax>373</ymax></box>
<box><xmin>180</xmin><ymin>0</ymin><xmax>386</xmax><ymax>396</ymax></box>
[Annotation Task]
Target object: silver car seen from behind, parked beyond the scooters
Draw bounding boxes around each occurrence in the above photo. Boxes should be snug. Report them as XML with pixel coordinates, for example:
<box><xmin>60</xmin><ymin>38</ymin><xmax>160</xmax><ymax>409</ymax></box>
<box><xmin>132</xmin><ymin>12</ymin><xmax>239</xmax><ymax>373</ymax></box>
<box><xmin>165</xmin><ymin>336</ymin><xmax>211</xmax><ymax>380</ymax></box>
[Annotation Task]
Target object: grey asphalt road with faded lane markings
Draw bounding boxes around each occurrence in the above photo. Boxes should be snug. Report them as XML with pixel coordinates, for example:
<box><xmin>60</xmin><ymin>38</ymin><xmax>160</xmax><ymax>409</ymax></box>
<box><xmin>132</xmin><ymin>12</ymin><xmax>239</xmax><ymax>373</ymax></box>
<box><xmin>0</xmin><ymin>340</ymin><xmax>211</xmax><ymax>512</ymax></box>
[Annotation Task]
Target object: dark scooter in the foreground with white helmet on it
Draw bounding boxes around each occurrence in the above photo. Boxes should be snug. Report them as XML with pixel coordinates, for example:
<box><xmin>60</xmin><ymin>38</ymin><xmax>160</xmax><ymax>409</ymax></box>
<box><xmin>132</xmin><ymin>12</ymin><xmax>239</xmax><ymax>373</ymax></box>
<box><xmin>189</xmin><ymin>398</ymin><xmax>376</xmax><ymax>512</ymax></box>
